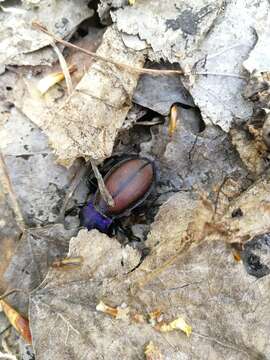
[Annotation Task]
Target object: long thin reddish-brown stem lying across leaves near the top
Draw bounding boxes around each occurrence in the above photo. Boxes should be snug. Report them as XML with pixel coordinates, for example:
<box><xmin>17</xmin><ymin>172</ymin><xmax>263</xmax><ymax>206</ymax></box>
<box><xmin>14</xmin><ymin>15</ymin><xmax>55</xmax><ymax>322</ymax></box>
<box><xmin>32</xmin><ymin>21</ymin><xmax>183</xmax><ymax>76</ymax></box>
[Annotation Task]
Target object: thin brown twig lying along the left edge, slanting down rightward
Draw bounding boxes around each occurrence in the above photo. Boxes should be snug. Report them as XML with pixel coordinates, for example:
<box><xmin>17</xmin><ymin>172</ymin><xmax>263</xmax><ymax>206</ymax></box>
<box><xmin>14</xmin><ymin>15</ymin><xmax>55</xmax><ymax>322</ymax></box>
<box><xmin>0</xmin><ymin>151</ymin><xmax>25</xmax><ymax>231</ymax></box>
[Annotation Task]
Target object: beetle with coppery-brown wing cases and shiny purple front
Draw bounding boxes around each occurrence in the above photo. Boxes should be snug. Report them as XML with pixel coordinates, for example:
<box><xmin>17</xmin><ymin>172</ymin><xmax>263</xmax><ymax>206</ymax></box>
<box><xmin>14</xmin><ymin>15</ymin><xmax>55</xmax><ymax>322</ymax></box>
<box><xmin>80</xmin><ymin>156</ymin><xmax>156</xmax><ymax>233</ymax></box>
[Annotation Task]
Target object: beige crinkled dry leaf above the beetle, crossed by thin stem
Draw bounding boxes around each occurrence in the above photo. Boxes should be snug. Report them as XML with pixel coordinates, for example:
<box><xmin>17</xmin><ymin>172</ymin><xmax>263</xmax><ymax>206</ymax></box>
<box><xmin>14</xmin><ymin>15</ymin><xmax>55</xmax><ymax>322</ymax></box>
<box><xmin>16</xmin><ymin>27</ymin><xmax>144</xmax><ymax>166</ymax></box>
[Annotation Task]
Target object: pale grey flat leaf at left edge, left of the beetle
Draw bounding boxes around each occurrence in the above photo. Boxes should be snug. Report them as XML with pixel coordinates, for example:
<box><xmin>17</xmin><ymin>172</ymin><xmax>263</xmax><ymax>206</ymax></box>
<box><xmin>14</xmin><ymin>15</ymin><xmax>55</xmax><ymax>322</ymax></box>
<box><xmin>0</xmin><ymin>107</ymin><xmax>87</xmax><ymax>226</ymax></box>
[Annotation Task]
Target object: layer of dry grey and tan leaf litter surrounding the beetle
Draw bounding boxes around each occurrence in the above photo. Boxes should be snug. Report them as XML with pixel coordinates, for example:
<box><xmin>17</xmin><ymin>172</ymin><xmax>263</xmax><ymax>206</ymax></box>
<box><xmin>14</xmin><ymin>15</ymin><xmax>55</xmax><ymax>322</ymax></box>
<box><xmin>0</xmin><ymin>0</ymin><xmax>270</xmax><ymax>359</ymax></box>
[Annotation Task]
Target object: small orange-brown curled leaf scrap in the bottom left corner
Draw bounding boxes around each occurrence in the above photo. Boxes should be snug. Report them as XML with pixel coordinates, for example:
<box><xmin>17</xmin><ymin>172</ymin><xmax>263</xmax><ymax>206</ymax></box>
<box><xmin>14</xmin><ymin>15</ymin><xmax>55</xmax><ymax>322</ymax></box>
<box><xmin>0</xmin><ymin>300</ymin><xmax>32</xmax><ymax>344</ymax></box>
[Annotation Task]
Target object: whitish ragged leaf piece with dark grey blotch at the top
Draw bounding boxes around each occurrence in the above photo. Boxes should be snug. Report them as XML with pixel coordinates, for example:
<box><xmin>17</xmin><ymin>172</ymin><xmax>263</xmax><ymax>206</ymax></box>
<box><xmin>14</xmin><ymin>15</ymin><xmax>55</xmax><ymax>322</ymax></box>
<box><xmin>110</xmin><ymin>0</ymin><xmax>222</xmax><ymax>62</ymax></box>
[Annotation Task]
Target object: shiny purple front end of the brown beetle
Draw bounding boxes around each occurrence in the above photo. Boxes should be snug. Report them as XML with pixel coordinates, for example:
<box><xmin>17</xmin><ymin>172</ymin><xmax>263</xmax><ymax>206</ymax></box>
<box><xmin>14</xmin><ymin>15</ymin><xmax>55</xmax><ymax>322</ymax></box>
<box><xmin>80</xmin><ymin>201</ymin><xmax>112</xmax><ymax>233</ymax></box>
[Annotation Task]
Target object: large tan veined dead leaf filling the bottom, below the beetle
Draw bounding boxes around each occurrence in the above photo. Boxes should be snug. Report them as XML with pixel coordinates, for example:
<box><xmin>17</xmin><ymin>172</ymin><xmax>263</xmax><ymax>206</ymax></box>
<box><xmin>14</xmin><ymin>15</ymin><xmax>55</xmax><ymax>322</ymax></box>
<box><xmin>26</xmin><ymin>200</ymin><xmax>270</xmax><ymax>360</ymax></box>
